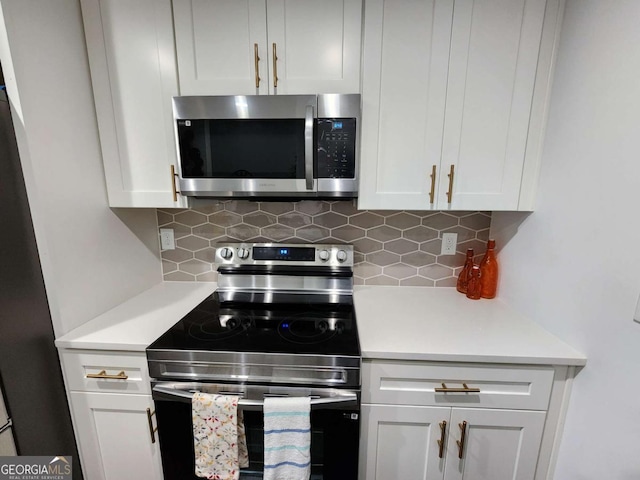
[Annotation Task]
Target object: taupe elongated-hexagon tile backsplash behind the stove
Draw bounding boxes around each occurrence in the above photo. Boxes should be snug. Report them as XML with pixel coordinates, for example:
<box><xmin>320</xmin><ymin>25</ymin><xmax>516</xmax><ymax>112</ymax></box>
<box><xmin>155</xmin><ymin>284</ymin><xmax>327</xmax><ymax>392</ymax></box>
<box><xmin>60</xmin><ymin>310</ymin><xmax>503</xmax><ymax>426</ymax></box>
<box><xmin>157</xmin><ymin>200</ymin><xmax>491</xmax><ymax>287</ymax></box>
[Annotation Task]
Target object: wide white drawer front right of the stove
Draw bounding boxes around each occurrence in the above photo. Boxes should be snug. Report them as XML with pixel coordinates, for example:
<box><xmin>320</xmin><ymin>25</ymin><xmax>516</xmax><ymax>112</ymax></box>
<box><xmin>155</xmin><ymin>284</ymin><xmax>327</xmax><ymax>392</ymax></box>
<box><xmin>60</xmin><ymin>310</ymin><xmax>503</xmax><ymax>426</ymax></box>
<box><xmin>362</xmin><ymin>361</ymin><xmax>554</xmax><ymax>410</ymax></box>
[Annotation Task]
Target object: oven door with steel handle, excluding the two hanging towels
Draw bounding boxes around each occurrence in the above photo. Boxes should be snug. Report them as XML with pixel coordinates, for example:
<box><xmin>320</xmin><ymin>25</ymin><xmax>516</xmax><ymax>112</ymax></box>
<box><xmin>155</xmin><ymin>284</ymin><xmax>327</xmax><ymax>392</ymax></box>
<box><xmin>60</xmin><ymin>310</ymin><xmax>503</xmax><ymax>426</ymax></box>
<box><xmin>153</xmin><ymin>383</ymin><xmax>360</xmax><ymax>480</ymax></box>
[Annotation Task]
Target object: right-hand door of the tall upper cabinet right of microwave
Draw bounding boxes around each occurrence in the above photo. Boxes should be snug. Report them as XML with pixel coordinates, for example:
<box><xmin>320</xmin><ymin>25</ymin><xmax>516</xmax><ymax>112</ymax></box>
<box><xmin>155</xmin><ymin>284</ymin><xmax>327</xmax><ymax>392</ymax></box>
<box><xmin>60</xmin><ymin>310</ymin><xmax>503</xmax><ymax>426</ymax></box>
<box><xmin>438</xmin><ymin>0</ymin><xmax>546</xmax><ymax>210</ymax></box>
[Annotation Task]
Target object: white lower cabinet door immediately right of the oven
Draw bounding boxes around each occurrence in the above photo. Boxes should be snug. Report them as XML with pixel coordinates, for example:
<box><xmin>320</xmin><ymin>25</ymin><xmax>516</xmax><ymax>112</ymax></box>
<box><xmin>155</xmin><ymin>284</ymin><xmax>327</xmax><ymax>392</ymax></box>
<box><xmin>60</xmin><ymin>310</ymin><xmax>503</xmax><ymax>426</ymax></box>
<box><xmin>359</xmin><ymin>405</ymin><xmax>451</xmax><ymax>480</ymax></box>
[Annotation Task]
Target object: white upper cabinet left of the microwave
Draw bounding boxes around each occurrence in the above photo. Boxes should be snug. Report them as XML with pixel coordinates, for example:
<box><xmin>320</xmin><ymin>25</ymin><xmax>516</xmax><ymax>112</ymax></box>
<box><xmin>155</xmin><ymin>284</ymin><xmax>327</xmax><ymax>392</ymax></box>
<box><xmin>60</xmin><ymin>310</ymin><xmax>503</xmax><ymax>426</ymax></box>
<box><xmin>81</xmin><ymin>0</ymin><xmax>186</xmax><ymax>207</ymax></box>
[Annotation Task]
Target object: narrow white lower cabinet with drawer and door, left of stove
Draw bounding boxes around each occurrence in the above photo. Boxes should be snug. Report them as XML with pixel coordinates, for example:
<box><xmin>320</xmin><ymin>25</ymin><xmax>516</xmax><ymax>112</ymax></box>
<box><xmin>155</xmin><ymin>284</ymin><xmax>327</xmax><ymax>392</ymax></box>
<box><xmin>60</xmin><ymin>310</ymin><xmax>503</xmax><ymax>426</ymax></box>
<box><xmin>60</xmin><ymin>350</ymin><xmax>163</xmax><ymax>480</ymax></box>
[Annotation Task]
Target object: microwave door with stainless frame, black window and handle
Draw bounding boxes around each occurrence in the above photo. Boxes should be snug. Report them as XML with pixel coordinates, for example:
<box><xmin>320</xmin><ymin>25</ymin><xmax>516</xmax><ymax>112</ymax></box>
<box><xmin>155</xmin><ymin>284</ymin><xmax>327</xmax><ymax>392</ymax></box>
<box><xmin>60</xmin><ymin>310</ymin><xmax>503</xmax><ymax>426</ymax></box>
<box><xmin>174</xmin><ymin>95</ymin><xmax>317</xmax><ymax>197</ymax></box>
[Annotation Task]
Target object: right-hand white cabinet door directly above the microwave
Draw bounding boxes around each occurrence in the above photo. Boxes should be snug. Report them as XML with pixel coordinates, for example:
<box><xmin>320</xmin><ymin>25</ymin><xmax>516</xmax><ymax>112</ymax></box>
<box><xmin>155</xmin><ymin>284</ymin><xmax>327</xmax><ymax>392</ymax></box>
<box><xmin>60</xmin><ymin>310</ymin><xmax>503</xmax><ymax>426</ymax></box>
<box><xmin>267</xmin><ymin>0</ymin><xmax>362</xmax><ymax>94</ymax></box>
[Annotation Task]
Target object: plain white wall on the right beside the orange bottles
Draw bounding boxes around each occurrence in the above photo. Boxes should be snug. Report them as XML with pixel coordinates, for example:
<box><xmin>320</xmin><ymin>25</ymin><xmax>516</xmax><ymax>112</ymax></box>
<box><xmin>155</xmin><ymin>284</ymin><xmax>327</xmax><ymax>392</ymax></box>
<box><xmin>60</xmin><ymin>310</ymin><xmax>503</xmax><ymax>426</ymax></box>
<box><xmin>494</xmin><ymin>0</ymin><xmax>640</xmax><ymax>480</ymax></box>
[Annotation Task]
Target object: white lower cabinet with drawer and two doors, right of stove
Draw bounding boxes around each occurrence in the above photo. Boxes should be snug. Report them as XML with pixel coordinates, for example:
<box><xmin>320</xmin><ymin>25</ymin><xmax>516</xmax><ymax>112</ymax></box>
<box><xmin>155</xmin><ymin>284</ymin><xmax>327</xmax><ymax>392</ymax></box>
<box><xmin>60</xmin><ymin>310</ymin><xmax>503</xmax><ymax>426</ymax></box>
<box><xmin>359</xmin><ymin>360</ymin><xmax>556</xmax><ymax>480</ymax></box>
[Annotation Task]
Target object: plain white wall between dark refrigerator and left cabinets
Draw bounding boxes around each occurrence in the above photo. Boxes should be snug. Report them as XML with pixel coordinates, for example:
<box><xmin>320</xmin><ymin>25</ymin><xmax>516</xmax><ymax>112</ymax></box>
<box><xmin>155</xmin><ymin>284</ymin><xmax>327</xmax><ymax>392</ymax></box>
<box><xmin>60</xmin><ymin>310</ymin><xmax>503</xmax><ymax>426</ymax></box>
<box><xmin>0</xmin><ymin>0</ymin><xmax>162</xmax><ymax>336</ymax></box>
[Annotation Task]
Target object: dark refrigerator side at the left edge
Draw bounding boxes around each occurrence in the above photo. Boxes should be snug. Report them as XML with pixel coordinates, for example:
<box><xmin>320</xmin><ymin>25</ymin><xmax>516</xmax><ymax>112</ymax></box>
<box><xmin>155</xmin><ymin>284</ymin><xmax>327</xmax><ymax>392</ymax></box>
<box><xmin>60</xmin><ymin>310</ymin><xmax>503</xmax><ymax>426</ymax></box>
<box><xmin>0</xmin><ymin>85</ymin><xmax>82</xmax><ymax>479</ymax></box>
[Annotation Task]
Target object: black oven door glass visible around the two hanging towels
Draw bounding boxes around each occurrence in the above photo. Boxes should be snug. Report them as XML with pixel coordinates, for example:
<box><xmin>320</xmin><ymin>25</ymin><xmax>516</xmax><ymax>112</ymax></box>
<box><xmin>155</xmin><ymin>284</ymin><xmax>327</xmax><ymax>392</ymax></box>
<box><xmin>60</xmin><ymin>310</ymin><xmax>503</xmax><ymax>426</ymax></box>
<box><xmin>156</xmin><ymin>401</ymin><xmax>360</xmax><ymax>480</ymax></box>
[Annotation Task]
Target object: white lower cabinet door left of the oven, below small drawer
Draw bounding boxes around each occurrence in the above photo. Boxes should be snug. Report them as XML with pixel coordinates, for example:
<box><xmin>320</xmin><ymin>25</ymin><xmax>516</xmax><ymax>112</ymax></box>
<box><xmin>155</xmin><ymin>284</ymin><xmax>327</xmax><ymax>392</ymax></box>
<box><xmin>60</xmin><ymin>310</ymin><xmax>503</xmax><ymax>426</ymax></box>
<box><xmin>71</xmin><ymin>392</ymin><xmax>162</xmax><ymax>480</ymax></box>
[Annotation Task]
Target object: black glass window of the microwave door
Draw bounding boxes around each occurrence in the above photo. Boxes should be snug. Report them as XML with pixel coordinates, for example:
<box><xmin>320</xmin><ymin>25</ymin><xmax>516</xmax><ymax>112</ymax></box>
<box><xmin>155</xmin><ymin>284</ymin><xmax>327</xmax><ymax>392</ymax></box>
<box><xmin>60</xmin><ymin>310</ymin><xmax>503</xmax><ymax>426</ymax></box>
<box><xmin>178</xmin><ymin>119</ymin><xmax>304</xmax><ymax>179</ymax></box>
